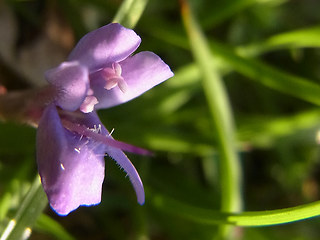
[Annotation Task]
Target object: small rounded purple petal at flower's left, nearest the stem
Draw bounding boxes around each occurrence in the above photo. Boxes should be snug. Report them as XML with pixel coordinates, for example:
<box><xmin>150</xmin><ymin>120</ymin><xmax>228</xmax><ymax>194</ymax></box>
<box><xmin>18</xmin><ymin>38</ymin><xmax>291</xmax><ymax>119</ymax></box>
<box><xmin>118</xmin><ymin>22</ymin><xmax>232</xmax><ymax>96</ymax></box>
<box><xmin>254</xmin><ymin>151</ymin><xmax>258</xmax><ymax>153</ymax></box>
<box><xmin>45</xmin><ymin>61</ymin><xmax>89</xmax><ymax>111</ymax></box>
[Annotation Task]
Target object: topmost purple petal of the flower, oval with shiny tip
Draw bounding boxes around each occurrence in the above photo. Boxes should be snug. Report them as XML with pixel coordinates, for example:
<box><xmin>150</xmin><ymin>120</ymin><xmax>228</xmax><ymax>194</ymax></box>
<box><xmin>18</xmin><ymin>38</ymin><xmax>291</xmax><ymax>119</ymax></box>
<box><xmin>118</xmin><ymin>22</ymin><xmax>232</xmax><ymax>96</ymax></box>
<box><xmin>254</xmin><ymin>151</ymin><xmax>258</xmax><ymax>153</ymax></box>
<box><xmin>68</xmin><ymin>23</ymin><xmax>141</xmax><ymax>72</ymax></box>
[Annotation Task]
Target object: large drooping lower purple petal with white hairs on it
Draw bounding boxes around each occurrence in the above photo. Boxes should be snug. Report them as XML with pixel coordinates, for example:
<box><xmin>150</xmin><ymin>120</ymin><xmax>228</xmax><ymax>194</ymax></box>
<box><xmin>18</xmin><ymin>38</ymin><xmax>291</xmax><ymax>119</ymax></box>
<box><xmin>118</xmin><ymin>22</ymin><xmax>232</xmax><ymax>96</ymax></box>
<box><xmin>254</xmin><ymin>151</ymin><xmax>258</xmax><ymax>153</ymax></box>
<box><xmin>37</xmin><ymin>105</ymin><xmax>105</xmax><ymax>215</ymax></box>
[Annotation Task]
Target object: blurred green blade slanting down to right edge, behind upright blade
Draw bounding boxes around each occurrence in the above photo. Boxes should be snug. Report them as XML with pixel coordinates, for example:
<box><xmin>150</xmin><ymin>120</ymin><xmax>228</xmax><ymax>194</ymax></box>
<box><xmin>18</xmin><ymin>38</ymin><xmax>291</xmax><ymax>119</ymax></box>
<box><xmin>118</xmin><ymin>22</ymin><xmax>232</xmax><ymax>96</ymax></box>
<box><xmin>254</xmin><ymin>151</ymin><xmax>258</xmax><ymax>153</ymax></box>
<box><xmin>149</xmin><ymin>23</ymin><xmax>320</xmax><ymax>105</ymax></box>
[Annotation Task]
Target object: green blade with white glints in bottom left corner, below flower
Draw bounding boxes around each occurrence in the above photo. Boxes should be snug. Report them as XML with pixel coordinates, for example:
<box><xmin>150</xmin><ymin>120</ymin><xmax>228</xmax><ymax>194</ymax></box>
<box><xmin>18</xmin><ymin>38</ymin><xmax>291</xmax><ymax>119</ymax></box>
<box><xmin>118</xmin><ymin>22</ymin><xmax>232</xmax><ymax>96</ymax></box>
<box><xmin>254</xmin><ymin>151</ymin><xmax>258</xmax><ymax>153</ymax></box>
<box><xmin>0</xmin><ymin>176</ymin><xmax>48</xmax><ymax>240</ymax></box>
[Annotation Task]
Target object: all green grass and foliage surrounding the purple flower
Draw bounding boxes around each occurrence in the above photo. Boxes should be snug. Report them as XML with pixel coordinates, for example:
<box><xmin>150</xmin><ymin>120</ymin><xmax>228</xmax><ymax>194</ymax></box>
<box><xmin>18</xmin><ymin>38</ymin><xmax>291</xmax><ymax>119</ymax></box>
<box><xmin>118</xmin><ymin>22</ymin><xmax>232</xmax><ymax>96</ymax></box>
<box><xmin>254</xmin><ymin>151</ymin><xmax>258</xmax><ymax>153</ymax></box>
<box><xmin>0</xmin><ymin>0</ymin><xmax>320</xmax><ymax>240</ymax></box>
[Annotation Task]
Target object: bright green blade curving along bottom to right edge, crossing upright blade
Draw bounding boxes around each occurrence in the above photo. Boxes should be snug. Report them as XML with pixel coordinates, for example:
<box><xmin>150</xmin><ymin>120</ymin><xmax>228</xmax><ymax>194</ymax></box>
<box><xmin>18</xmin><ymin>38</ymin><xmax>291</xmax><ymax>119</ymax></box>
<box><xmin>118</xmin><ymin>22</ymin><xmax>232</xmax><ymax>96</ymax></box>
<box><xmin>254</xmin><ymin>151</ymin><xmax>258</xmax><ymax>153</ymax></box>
<box><xmin>152</xmin><ymin>191</ymin><xmax>320</xmax><ymax>227</ymax></box>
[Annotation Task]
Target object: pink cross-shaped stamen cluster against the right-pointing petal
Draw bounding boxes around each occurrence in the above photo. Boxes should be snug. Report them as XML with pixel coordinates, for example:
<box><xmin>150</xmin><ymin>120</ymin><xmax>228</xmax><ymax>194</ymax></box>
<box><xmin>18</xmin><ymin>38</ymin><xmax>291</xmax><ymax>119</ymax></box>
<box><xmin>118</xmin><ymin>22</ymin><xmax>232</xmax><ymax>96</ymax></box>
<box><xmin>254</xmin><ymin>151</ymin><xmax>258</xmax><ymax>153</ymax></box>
<box><xmin>102</xmin><ymin>62</ymin><xmax>128</xmax><ymax>93</ymax></box>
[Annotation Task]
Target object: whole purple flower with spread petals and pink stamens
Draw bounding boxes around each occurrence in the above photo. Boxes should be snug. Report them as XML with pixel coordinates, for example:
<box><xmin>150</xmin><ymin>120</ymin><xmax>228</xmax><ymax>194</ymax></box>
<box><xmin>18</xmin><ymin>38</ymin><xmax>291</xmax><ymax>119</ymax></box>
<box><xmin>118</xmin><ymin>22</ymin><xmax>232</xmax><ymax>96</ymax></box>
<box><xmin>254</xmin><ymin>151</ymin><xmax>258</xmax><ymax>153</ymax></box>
<box><xmin>37</xmin><ymin>23</ymin><xmax>173</xmax><ymax>215</ymax></box>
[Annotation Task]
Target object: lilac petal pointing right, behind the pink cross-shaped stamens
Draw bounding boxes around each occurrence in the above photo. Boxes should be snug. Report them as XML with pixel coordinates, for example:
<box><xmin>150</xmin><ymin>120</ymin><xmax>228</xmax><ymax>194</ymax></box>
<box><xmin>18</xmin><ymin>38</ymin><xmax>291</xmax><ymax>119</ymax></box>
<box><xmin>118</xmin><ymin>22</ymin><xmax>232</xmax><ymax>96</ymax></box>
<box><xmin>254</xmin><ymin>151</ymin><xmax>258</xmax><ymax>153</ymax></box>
<box><xmin>90</xmin><ymin>52</ymin><xmax>173</xmax><ymax>109</ymax></box>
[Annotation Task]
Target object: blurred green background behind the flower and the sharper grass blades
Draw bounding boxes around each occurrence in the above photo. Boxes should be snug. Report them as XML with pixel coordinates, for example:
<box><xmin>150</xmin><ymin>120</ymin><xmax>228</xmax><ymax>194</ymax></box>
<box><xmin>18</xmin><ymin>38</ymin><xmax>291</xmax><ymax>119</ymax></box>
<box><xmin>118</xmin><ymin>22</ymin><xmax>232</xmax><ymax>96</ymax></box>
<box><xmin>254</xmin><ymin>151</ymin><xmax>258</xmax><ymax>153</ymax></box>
<box><xmin>0</xmin><ymin>0</ymin><xmax>320</xmax><ymax>240</ymax></box>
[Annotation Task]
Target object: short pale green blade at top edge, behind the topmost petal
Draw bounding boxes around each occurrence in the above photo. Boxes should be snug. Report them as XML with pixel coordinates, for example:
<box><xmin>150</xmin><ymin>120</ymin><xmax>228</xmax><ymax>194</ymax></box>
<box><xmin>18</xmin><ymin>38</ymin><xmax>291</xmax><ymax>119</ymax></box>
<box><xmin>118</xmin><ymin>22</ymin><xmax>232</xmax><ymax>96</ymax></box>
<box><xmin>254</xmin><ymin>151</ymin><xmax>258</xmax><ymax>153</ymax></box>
<box><xmin>113</xmin><ymin>0</ymin><xmax>148</xmax><ymax>28</ymax></box>
